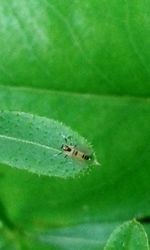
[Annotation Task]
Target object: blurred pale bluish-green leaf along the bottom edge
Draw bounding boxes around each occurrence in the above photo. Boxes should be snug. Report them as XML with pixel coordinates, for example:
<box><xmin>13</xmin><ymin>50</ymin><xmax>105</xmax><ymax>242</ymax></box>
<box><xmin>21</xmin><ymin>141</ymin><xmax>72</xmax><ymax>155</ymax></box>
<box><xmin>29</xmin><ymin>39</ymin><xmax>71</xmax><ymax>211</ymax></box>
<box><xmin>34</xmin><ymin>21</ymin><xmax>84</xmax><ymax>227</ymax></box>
<box><xmin>36</xmin><ymin>223</ymin><xmax>116</xmax><ymax>250</ymax></box>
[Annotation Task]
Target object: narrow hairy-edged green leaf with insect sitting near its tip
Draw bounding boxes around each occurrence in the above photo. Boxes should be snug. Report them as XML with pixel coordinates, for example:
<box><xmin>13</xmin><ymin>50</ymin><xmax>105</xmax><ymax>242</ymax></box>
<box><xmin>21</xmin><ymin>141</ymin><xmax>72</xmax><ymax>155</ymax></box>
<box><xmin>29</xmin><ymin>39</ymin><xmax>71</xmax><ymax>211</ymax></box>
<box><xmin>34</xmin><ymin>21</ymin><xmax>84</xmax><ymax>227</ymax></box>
<box><xmin>0</xmin><ymin>111</ymin><xmax>98</xmax><ymax>178</ymax></box>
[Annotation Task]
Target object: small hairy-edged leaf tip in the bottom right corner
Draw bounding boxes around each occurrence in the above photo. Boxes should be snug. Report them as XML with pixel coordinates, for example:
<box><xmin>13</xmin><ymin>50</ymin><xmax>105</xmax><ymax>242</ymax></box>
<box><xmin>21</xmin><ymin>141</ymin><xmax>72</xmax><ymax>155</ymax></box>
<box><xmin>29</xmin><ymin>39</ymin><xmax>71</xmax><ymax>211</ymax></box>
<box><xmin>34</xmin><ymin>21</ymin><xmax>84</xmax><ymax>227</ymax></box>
<box><xmin>104</xmin><ymin>220</ymin><xmax>149</xmax><ymax>250</ymax></box>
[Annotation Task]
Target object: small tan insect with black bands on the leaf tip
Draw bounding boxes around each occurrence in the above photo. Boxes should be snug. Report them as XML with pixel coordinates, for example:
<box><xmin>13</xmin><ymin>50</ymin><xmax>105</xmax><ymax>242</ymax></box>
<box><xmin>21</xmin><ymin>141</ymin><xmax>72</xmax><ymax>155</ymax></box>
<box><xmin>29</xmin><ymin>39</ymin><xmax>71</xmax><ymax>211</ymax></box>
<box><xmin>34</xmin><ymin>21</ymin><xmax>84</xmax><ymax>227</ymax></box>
<box><xmin>61</xmin><ymin>138</ymin><xmax>92</xmax><ymax>161</ymax></box>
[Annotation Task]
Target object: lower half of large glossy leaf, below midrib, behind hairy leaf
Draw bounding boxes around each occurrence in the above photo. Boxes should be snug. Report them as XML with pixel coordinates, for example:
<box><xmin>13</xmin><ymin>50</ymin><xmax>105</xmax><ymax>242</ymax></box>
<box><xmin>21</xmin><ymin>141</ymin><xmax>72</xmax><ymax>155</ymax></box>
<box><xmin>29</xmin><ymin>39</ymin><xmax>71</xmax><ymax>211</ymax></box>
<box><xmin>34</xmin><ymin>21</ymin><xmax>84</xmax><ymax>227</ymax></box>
<box><xmin>0</xmin><ymin>87</ymin><xmax>150</xmax><ymax>249</ymax></box>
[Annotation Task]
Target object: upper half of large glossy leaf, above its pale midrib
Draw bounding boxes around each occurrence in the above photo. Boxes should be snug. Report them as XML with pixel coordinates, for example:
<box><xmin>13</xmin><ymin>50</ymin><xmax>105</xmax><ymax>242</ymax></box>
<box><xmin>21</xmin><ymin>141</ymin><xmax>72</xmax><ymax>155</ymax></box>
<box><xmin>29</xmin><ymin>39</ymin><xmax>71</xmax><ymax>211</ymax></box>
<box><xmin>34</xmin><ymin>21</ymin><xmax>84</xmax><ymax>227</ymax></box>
<box><xmin>0</xmin><ymin>0</ymin><xmax>150</xmax><ymax>96</ymax></box>
